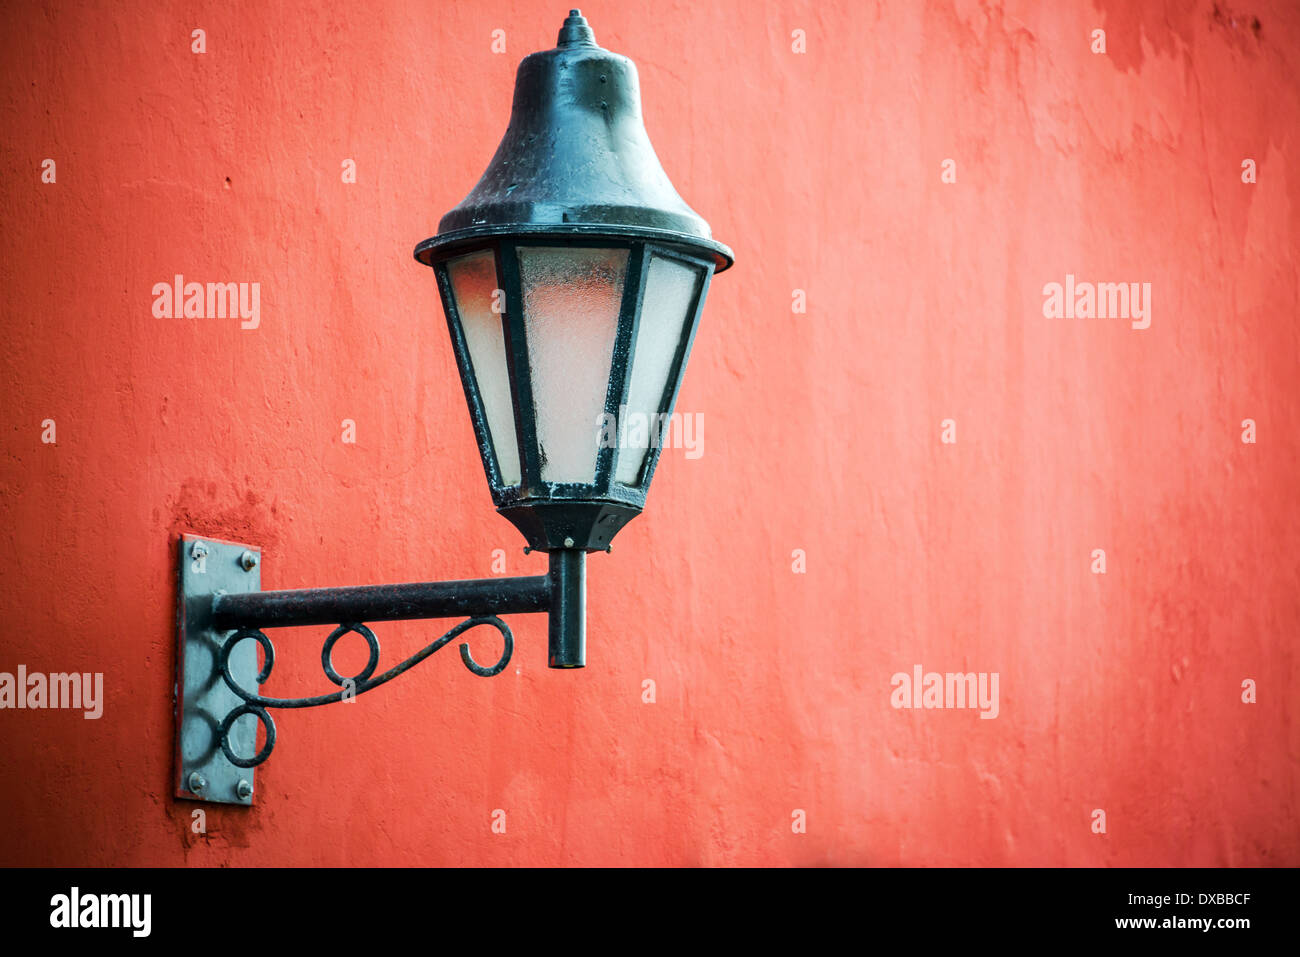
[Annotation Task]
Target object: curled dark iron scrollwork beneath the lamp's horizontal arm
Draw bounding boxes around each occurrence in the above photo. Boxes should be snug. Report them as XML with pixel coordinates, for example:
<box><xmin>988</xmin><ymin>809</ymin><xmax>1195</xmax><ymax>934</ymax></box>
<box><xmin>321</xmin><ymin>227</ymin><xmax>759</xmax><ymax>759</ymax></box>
<box><xmin>217</xmin><ymin>615</ymin><xmax>515</xmax><ymax>767</ymax></box>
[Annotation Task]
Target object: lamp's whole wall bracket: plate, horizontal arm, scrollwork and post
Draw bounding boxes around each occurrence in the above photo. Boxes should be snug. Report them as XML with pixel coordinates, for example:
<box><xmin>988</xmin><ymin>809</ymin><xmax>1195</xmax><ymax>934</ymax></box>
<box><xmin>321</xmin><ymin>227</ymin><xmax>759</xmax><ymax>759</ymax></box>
<box><xmin>177</xmin><ymin>540</ymin><xmax>586</xmax><ymax>804</ymax></box>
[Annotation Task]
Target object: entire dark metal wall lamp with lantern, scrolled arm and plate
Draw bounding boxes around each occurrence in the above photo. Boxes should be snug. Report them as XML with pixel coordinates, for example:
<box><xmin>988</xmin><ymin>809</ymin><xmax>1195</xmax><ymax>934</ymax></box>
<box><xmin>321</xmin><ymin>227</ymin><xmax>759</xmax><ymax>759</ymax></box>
<box><xmin>176</xmin><ymin>10</ymin><xmax>733</xmax><ymax>804</ymax></box>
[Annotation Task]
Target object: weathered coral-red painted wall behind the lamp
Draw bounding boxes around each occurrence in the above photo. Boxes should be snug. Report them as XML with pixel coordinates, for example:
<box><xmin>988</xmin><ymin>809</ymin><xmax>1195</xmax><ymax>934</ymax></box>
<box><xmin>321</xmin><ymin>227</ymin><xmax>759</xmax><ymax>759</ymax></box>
<box><xmin>0</xmin><ymin>0</ymin><xmax>1300</xmax><ymax>865</ymax></box>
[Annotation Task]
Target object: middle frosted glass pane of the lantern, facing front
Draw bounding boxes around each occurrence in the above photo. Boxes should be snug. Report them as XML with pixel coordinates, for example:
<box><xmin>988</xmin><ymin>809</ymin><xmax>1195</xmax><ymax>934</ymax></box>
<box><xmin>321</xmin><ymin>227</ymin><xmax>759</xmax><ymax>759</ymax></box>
<box><xmin>519</xmin><ymin>246</ymin><xmax>628</xmax><ymax>482</ymax></box>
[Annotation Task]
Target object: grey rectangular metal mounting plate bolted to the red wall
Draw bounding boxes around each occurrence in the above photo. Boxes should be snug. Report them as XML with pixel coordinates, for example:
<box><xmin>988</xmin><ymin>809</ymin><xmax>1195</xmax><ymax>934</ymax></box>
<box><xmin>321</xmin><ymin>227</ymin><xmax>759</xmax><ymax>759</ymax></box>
<box><xmin>174</xmin><ymin>534</ymin><xmax>261</xmax><ymax>805</ymax></box>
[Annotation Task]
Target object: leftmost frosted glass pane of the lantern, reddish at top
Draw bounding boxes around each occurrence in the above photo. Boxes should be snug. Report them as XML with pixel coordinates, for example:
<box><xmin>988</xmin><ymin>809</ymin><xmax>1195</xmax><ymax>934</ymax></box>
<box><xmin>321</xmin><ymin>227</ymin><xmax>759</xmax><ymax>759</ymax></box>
<box><xmin>447</xmin><ymin>250</ymin><xmax>519</xmax><ymax>485</ymax></box>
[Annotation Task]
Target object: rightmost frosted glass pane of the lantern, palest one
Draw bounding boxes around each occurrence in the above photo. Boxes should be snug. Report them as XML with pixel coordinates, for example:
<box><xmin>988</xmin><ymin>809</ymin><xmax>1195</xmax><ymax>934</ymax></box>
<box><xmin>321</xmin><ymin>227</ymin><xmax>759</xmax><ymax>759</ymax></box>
<box><xmin>614</xmin><ymin>256</ymin><xmax>701</xmax><ymax>485</ymax></box>
